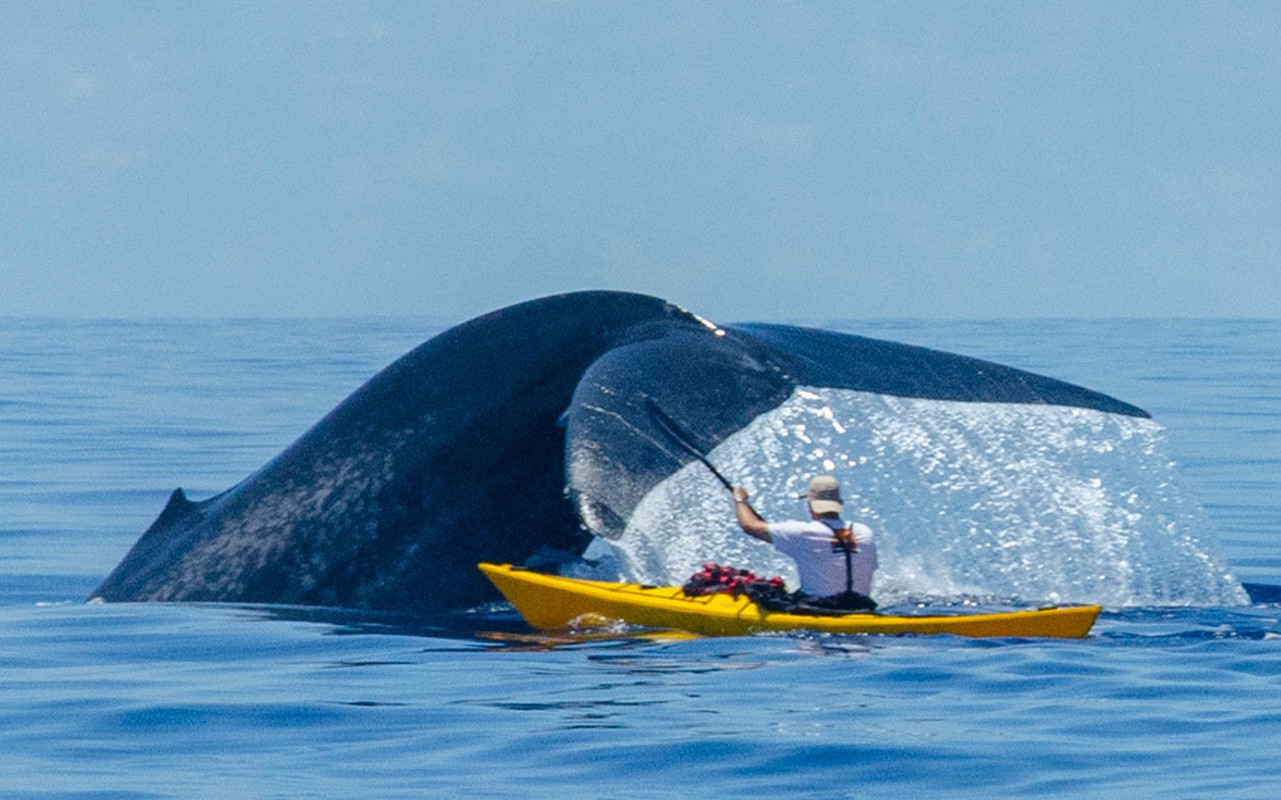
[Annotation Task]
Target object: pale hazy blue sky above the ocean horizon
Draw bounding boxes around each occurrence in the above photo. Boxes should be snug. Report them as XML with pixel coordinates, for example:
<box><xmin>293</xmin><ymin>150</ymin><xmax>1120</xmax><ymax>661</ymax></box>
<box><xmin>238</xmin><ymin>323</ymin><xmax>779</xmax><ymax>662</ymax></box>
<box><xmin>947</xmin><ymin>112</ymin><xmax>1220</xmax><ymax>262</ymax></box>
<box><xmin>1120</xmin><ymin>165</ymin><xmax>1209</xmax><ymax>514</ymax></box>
<box><xmin>0</xmin><ymin>1</ymin><xmax>1281</xmax><ymax>321</ymax></box>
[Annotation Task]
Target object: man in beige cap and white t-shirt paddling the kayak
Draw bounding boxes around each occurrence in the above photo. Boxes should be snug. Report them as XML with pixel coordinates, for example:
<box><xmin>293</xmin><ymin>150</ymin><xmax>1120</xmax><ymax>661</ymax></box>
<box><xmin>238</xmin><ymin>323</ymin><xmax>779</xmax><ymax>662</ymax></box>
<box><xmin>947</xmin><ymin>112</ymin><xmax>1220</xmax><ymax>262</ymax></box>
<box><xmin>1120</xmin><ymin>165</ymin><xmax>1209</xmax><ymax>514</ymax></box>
<box><xmin>734</xmin><ymin>475</ymin><xmax>876</xmax><ymax>611</ymax></box>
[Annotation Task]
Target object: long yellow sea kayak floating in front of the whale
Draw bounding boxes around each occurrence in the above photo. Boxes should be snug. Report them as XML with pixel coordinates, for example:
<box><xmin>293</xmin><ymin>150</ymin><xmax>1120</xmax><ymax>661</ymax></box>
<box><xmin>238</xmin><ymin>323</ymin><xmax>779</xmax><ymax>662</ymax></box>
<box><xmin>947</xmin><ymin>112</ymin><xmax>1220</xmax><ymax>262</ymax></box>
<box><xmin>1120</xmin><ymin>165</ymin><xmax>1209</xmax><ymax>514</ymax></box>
<box><xmin>479</xmin><ymin>563</ymin><xmax>1103</xmax><ymax>639</ymax></box>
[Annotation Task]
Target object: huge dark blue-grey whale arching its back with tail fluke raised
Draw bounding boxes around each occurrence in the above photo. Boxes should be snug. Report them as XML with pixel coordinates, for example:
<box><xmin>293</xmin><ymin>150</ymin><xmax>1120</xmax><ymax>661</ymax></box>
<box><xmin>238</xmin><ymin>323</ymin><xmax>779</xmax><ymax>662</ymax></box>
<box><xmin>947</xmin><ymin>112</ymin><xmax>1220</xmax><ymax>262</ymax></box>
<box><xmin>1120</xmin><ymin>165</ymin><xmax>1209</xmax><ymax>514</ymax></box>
<box><xmin>94</xmin><ymin>292</ymin><xmax>1148</xmax><ymax>614</ymax></box>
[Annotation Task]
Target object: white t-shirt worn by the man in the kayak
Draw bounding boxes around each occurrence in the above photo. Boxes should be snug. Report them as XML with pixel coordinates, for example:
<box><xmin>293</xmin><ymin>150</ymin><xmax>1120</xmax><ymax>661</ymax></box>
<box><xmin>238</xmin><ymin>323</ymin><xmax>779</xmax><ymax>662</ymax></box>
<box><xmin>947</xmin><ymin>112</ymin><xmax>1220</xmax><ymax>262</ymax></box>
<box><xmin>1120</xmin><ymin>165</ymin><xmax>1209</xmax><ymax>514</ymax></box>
<box><xmin>770</xmin><ymin>520</ymin><xmax>876</xmax><ymax>596</ymax></box>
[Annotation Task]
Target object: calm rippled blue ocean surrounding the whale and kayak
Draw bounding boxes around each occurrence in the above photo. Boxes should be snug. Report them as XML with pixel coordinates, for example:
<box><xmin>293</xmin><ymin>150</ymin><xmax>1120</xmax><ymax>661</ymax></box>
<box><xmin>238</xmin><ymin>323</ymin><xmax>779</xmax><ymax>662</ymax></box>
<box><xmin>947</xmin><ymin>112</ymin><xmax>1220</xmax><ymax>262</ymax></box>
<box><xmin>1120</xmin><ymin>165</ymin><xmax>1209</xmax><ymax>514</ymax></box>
<box><xmin>0</xmin><ymin>319</ymin><xmax>1281</xmax><ymax>799</ymax></box>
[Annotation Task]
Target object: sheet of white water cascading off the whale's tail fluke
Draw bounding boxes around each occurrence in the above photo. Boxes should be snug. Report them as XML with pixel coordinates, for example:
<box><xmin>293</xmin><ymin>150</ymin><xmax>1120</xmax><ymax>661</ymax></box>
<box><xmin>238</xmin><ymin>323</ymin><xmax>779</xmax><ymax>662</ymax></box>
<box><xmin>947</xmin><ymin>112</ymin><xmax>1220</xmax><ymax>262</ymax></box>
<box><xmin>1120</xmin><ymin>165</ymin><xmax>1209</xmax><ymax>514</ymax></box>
<box><xmin>586</xmin><ymin>388</ymin><xmax>1248</xmax><ymax>607</ymax></box>
